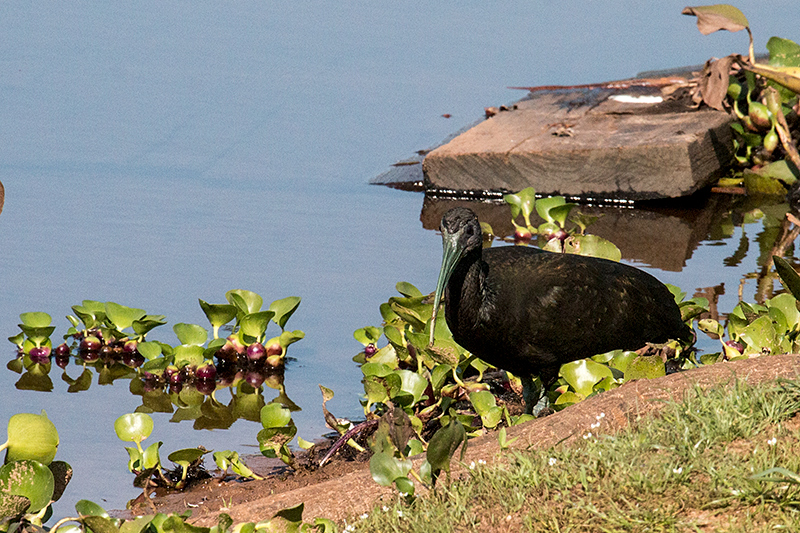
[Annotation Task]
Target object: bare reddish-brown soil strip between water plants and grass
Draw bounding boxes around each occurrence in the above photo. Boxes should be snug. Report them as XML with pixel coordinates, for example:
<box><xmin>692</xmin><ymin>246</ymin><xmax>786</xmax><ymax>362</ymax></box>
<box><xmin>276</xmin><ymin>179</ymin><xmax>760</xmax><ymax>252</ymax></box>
<box><xmin>115</xmin><ymin>355</ymin><xmax>800</xmax><ymax>526</ymax></box>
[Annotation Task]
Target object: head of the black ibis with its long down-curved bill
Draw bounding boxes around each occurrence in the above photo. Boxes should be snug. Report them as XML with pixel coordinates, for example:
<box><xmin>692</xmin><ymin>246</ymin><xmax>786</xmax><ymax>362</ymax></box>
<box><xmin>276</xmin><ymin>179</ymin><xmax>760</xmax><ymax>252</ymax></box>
<box><xmin>430</xmin><ymin>207</ymin><xmax>483</xmax><ymax>344</ymax></box>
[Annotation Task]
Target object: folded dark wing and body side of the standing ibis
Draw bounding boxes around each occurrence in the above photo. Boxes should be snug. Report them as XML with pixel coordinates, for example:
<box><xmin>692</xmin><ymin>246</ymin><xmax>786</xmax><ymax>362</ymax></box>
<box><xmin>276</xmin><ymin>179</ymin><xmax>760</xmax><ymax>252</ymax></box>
<box><xmin>475</xmin><ymin>247</ymin><xmax>688</xmax><ymax>373</ymax></box>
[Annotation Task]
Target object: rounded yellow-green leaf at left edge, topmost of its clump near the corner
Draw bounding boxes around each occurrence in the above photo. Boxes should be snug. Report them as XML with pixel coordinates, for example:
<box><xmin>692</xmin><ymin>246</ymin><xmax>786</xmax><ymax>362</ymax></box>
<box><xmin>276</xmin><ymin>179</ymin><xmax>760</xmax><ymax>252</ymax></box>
<box><xmin>6</xmin><ymin>410</ymin><xmax>58</xmax><ymax>465</ymax></box>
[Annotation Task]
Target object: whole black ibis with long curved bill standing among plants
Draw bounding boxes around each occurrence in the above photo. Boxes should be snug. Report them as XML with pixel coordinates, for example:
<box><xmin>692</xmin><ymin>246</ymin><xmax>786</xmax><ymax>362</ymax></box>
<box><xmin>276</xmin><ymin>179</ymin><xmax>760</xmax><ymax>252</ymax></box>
<box><xmin>430</xmin><ymin>207</ymin><xmax>694</xmax><ymax>413</ymax></box>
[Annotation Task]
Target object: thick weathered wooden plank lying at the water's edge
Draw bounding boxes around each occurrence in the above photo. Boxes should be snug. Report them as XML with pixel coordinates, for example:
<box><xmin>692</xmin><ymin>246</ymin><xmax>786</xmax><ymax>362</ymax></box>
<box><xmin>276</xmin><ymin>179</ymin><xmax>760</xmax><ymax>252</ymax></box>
<box><xmin>423</xmin><ymin>89</ymin><xmax>732</xmax><ymax>200</ymax></box>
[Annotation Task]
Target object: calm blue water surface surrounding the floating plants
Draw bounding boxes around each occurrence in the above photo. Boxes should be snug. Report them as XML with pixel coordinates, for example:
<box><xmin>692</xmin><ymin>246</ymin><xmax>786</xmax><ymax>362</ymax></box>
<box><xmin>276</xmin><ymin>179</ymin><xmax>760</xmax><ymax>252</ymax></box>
<box><xmin>0</xmin><ymin>0</ymin><xmax>800</xmax><ymax>516</ymax></box>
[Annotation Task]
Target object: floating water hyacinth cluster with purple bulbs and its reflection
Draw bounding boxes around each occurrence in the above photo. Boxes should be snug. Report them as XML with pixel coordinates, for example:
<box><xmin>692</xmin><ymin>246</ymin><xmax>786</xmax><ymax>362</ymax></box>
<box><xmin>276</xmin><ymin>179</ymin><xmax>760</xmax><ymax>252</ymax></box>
<box><xmin>8</xmin><ymin>289</ymin><xmax>305</xmax><ymax>429</ymax></box>
